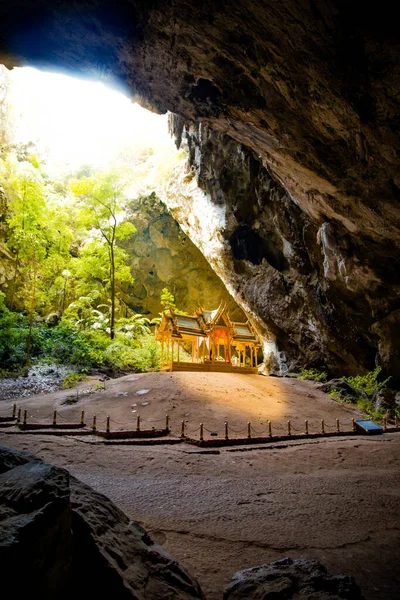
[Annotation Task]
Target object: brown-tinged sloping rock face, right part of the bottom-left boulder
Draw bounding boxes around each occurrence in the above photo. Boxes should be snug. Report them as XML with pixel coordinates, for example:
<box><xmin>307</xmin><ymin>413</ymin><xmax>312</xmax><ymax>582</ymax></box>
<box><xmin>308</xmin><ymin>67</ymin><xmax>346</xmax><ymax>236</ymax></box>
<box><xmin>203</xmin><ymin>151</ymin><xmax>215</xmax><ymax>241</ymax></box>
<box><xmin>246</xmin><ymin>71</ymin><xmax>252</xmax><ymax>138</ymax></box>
<box><xmin>71</xmin><ymin>478</ymin><xmax>203</xmax><ymax>600</ymax></box>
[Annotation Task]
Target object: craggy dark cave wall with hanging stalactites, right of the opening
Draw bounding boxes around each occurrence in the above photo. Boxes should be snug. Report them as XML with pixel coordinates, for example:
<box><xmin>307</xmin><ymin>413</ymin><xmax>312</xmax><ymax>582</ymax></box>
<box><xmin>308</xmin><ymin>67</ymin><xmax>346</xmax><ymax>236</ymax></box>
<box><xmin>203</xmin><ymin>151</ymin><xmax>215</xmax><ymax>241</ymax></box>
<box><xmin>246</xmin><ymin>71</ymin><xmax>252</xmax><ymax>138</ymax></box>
<box><xmin>165</xmin><ymin>116</ymin><xmax>387</xmax><ymax>374</ymax></box>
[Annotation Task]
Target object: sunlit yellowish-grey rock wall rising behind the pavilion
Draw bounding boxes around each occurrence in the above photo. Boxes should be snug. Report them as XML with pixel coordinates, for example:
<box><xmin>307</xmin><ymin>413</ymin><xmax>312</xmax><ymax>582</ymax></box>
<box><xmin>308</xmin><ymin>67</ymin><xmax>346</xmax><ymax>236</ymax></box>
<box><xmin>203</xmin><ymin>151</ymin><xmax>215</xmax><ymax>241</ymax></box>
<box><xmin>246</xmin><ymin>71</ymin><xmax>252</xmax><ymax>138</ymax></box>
<box><xmin>120</xmin><ymin>194</ymin><xmax>245</xmax><ymax>321</ymax></box>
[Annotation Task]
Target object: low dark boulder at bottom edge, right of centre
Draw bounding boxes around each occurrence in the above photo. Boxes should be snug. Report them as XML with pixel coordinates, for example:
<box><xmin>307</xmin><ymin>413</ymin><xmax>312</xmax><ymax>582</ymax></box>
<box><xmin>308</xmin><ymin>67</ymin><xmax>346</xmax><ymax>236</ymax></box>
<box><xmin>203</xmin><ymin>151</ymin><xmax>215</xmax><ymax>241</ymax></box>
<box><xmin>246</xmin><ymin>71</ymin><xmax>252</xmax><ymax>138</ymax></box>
<box><xmin>224</xmin><ymin>558</ymin><xmax>362</xmax><ymax>600</ymax></box>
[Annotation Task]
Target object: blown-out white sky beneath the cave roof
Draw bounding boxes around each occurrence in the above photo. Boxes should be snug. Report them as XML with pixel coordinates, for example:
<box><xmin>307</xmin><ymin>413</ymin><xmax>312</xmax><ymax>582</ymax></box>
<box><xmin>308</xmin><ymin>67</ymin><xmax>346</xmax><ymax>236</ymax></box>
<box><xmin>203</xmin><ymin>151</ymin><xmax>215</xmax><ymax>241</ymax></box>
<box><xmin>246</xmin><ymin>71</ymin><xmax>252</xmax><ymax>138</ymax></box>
<box><xmin>6</xmin><ymin>67</ymin><xmax>173</xmax><ymax>176</ymax></box>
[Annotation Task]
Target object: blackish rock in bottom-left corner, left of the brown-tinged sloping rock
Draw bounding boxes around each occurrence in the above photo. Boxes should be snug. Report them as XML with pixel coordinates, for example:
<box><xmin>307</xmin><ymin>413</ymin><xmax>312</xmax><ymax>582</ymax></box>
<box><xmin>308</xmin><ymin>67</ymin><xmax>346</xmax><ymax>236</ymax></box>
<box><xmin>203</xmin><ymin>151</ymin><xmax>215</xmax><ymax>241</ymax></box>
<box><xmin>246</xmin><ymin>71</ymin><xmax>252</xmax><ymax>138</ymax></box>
<box><xmin>0</xmin><ymin>458</ymin><xmax>72</xmax><ymax>600</ymax></box>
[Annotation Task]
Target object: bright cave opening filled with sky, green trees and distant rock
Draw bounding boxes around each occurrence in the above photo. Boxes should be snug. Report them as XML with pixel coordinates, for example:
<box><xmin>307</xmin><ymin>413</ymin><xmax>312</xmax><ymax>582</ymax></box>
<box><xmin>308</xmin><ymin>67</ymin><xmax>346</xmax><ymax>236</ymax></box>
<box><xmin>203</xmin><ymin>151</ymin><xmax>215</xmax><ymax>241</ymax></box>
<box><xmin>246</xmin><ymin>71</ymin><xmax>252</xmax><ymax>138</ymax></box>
<box><xmin>0</xmin><ymin>67</ymin><xmax>247</xmax><ymax>376</ymax></box>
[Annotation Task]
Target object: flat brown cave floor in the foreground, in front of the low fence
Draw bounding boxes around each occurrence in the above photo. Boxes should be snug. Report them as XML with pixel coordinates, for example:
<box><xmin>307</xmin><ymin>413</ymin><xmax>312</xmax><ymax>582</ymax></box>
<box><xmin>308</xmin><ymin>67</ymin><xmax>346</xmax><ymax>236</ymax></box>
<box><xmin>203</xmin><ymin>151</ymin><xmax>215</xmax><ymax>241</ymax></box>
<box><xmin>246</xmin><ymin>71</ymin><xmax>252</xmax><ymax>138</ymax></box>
<box><xmin>0</xmin><ymin>433</ymin><xmax>400</xmax><ymax>600</ymax></box>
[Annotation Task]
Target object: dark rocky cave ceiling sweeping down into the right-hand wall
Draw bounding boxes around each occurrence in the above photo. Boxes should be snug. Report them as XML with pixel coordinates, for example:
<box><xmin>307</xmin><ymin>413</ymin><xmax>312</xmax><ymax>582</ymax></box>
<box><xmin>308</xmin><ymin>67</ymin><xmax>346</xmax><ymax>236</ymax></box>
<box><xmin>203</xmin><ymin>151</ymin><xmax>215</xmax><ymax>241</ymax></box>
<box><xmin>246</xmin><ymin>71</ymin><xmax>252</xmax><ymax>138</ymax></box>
<box><xmin>0</xmin><ymin>0</ymin><xmax>400</xmax><ymax>376</ymax></box>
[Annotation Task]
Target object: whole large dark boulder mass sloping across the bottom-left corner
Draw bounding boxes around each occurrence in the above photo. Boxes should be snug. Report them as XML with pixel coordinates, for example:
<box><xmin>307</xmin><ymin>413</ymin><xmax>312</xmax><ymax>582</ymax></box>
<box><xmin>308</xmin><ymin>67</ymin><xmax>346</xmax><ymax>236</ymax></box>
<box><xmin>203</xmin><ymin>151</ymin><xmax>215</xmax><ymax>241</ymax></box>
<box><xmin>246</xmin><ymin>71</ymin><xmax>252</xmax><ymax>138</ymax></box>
<box><xmin>0</xmin><ymin>447</ymin><xmax>204</xmax><ymax>600</ymax></box>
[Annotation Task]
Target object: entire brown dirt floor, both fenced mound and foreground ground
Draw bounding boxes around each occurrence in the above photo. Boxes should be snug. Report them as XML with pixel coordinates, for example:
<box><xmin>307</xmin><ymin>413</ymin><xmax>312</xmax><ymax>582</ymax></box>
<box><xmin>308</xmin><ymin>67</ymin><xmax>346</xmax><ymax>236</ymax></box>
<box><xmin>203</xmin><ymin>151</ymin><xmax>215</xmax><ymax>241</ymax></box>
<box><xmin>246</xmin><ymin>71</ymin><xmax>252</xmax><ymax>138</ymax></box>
<box><xmin>0</xmin><ymin>373</ymin><xmax>400</xmax><ymax>600</ymax></box>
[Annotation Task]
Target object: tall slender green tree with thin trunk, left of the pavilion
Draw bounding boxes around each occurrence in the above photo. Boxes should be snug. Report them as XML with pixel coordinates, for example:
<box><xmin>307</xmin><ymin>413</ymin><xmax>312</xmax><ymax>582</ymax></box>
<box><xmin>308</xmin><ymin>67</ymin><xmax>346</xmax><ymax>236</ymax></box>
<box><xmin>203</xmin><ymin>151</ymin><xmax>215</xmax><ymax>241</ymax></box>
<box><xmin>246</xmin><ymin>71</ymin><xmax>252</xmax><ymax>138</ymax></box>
<box><xmin>71</xmin><ymin>171</ymin><xmax>136</xmax><ymax>339</ymax></box>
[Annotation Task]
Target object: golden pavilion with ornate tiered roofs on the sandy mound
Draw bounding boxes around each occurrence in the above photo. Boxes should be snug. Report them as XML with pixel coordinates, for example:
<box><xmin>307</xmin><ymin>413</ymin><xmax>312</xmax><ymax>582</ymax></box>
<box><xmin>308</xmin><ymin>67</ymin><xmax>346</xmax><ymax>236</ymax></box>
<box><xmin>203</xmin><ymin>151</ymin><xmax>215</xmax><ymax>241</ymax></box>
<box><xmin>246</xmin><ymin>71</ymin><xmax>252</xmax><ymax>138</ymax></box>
<box><xmin>156</xmin><ymin>303</ymin><xmax>262</xmax><ymax>373</ymax></box>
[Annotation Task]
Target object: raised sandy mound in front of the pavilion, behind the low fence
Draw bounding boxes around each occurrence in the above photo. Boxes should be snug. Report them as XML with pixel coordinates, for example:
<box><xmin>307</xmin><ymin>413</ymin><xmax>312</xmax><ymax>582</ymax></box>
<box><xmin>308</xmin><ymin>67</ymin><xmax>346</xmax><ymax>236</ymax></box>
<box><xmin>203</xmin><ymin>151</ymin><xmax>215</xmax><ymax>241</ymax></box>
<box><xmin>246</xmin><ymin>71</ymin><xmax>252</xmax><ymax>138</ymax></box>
<box><xmin>0</xmin><ymin>372</ymin><xmax>366</xmax><ymax>437</ymax></box>
